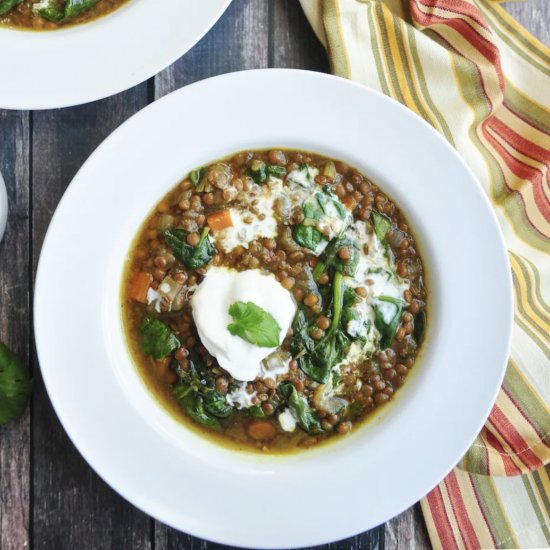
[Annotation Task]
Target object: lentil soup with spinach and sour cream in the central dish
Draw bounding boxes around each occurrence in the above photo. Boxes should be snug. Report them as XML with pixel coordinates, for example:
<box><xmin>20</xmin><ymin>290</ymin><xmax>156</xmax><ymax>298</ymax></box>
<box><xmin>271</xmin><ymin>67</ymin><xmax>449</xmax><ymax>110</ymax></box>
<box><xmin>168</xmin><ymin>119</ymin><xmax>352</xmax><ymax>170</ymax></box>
<box><xmin>122</xmin><ymin>150</ymin><xmax>427</xmax><ymax>453</ymax></box>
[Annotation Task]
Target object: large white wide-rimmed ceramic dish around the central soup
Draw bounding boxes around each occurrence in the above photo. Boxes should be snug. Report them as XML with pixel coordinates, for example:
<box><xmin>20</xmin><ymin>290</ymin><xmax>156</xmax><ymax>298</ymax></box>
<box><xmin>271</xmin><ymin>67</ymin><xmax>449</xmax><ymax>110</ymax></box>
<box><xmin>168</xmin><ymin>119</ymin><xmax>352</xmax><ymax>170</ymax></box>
<box><xmin>35</xmin><ymin>70</ymin><xmax>512</xmax><ymax>548</ymax></box>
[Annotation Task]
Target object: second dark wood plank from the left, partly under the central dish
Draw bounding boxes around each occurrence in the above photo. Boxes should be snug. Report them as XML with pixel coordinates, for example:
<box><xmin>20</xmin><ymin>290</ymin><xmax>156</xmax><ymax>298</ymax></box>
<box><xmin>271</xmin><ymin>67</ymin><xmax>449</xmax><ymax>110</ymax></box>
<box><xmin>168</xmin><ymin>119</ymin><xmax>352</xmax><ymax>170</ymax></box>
<box><xmin>32</xmin><ymin>88</ymin><xmax>151</xmax><ymax>550</ymax></box>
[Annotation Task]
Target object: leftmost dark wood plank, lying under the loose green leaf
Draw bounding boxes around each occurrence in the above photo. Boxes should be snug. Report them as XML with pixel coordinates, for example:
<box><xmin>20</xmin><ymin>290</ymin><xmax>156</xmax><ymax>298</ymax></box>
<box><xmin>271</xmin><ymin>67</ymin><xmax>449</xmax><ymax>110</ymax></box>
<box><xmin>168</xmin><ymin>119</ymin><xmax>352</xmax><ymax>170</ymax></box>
<box><xmin>0</xmin><ymin>111</ymin><xmax>31</xmax><ymax>550</ymax></box>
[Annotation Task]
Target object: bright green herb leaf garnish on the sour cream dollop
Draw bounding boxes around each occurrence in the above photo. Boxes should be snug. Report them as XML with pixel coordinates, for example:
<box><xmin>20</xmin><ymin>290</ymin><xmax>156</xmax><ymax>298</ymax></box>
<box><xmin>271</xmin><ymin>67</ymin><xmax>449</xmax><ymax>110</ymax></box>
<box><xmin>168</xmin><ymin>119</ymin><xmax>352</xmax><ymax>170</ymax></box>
<box><xmin>227</xmin><ymin>302</ymin><xmax>281</xmax><ymax>348</ymax></box>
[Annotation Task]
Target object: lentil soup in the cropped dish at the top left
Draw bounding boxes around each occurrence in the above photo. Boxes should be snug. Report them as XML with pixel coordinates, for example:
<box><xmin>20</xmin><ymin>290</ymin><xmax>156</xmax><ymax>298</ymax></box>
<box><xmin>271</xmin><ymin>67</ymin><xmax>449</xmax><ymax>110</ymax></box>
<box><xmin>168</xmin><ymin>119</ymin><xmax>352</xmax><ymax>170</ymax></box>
<box><xmin>0</xmin><ymin>0</ymin><xmax>129</xmax><ymax>31</ymax></box>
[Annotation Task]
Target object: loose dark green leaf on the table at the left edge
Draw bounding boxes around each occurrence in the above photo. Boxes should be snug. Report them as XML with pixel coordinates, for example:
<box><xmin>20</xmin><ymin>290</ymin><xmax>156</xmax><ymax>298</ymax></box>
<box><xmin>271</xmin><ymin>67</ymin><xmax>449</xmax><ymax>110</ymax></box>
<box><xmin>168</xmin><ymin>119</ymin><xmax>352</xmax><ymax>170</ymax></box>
<box><xmin>0</xmin><ymin>342</ymin><xmax>32</xmax><ymax>424</ymax></box>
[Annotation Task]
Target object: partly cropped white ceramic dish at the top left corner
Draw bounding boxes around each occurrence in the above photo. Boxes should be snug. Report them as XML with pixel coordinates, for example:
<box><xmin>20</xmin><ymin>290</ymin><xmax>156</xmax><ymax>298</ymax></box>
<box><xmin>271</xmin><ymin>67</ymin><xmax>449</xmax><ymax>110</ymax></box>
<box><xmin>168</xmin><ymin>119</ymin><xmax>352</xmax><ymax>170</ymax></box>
<box><xmin>0</xmin><ymin>0</ymin><xmax>231</xmax><ymax>109</ymax></box>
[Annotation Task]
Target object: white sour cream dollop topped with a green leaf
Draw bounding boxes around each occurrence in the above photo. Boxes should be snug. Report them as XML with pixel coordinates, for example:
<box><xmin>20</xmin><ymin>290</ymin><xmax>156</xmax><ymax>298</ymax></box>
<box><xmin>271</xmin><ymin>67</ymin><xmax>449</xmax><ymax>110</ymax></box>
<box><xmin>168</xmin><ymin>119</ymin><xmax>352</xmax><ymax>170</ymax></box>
<box><xmin>191</xmin><ymin>267</ymin><xmax>296</xmax><ymax>381</ymax></box>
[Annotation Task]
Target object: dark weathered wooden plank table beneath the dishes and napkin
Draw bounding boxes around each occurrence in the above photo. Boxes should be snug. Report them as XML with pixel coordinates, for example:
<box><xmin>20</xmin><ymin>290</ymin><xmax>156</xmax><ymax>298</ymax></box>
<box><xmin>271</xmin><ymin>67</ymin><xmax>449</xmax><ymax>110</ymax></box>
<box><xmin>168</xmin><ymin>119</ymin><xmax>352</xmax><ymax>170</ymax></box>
<box><xmin>0</xmin><ymin>0</ymin><xmax>550</xmax><ymax>550</ymax></box>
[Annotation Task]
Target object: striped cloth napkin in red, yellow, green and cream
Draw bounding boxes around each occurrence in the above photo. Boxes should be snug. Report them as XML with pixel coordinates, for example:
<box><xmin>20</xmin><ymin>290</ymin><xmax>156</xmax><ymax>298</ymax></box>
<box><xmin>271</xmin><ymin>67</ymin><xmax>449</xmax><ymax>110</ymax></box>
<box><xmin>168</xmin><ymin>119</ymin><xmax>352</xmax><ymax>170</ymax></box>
<box><xmin>300</xmin><ymin>0</ymin><xmax>550</xmax><ymax>550</ymax></box>
